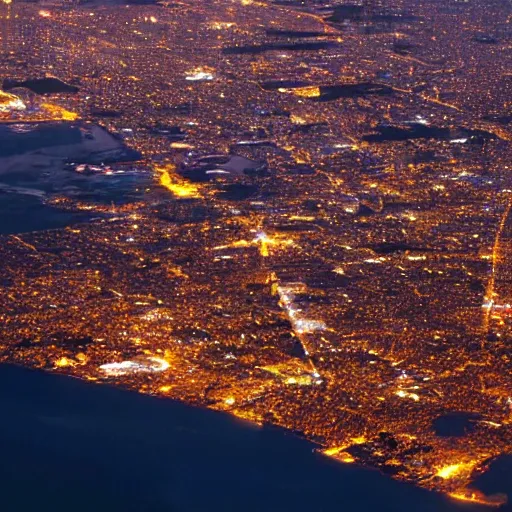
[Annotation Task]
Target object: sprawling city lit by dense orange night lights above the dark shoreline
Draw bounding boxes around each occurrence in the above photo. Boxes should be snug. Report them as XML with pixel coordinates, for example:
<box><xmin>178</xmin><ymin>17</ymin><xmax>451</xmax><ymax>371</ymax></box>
<box><xmin>0</xmin><ymin>0</ymin><xmax>512</xmax><ymax>504</ymax></box>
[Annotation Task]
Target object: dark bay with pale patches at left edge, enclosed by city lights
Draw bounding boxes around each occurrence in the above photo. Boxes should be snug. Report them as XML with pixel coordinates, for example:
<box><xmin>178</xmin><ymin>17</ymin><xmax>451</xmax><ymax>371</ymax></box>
<box><xmin>0</xmin><ymin>122</ymin><xmax>148</xmax><ymax>234</ymax></box>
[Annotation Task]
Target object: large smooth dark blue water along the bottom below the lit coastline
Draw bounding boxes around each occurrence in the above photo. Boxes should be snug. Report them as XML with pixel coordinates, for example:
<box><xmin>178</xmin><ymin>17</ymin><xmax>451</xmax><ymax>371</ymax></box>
<box><xmin>0</xmin><ymin>365</ymin><xmax>498</xmax><ymax>512</ymax></box>
